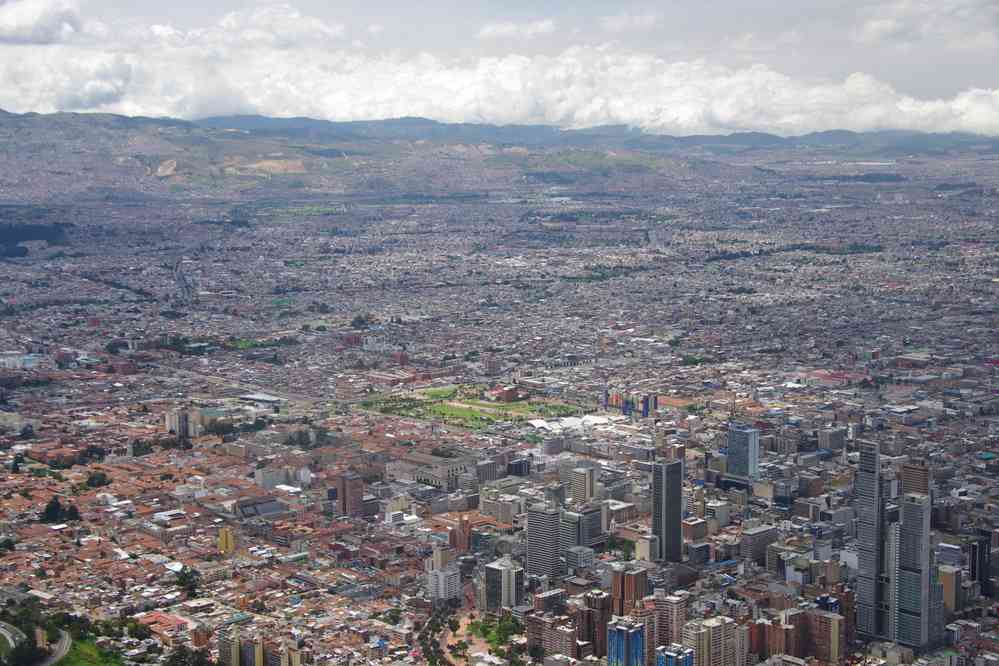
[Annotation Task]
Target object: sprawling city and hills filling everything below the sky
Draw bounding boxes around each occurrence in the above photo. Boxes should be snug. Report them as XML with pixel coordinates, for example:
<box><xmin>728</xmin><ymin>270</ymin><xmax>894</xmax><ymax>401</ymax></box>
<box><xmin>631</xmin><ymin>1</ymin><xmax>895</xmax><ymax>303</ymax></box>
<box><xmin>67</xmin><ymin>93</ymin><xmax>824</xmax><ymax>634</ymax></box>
<box><xmin>0</xmin><ymin>105</ymin><xmax>999</xmax><ymax>666</ymax></box>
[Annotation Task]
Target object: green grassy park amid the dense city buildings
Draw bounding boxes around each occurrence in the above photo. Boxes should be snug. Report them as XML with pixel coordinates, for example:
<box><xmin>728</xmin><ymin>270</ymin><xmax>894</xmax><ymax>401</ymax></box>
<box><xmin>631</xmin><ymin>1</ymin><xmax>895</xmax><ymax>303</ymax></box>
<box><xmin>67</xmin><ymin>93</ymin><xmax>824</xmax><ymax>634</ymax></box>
<box><xmin>364</xmin><ymin>386</ymin><xmax>582</xmax><ymax>430</ymax></box>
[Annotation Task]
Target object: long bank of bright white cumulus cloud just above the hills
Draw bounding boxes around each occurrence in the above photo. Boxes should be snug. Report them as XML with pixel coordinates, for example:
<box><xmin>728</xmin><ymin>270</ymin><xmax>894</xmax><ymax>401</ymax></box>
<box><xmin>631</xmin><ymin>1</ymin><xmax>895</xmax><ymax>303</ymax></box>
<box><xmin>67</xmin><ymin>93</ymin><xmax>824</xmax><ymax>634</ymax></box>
<box><xmin>0</xmin><ymin>5</ymin><xmax>999</xmax><ymax>135</ymax></box>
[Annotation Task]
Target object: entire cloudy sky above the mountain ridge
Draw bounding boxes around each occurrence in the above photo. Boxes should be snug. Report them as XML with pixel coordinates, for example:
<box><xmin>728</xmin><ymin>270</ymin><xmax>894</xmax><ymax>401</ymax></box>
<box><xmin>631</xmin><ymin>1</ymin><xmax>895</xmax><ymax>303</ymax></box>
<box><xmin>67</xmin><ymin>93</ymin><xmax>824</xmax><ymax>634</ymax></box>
<box><xmin>0</xmin><ymin>0</ymin><xmax>999</xmax><ymax>135</ymax></box>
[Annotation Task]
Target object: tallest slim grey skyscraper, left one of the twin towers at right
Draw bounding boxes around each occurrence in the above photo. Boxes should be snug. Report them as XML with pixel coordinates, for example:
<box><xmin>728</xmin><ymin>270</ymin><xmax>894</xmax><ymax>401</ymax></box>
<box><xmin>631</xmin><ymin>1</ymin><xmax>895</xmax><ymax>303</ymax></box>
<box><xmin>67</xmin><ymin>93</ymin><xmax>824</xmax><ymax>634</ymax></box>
<box><xmin>853</xmin><ymin>441</ymin><xmax>890</xmax><ymax>640</ymax></box>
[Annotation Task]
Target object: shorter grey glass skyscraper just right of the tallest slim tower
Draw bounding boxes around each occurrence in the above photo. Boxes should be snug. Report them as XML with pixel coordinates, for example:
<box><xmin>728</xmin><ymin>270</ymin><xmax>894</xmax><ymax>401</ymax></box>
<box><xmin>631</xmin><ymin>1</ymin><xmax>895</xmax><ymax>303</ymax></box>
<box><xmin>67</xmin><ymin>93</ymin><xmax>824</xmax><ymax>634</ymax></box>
<box><xmin>895</xmin><ymin>493</ymin><xmax>935</xmax><ymax>648</ymax></box>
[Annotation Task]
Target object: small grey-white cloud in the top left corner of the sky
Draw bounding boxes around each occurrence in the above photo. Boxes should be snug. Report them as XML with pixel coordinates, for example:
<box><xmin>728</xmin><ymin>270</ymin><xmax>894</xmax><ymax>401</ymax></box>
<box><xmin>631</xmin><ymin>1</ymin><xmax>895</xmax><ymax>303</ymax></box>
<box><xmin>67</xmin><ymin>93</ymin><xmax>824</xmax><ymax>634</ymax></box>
<box><xmin>0</xmin><ymin>0</ymin><xmax>83</xmax><ymax>44</ymax></box>
